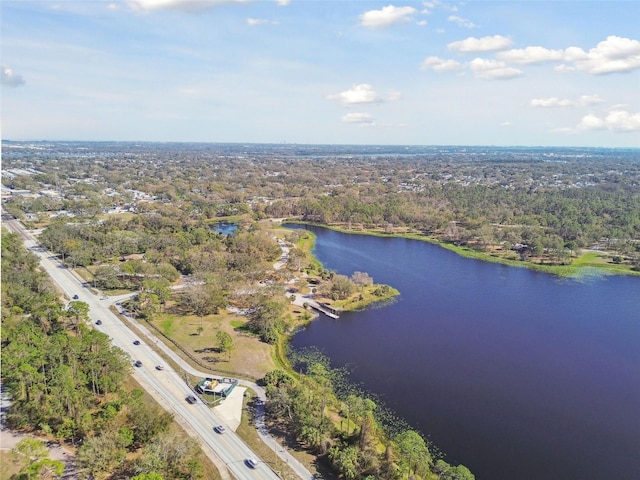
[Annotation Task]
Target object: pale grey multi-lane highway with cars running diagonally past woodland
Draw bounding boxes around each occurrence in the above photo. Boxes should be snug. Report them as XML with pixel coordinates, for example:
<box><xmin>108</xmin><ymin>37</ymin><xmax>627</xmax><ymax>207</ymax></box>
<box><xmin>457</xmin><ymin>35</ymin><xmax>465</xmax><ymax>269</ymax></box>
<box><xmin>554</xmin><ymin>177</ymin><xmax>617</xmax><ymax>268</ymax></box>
<box><xmin>2</xmin><ymin>214</ymin><xmax>313</xmax><ymax>480</ymax></box>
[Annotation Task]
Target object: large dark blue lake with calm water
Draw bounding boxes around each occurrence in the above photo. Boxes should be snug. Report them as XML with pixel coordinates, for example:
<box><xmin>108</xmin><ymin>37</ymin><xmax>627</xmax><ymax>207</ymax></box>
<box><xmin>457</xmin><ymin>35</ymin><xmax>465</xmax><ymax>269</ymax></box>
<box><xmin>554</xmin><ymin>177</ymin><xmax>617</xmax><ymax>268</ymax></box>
<box><xmin>293</xmin><ymin>227</ymin><xmax>640</xmax><ymax>480</ymax></box>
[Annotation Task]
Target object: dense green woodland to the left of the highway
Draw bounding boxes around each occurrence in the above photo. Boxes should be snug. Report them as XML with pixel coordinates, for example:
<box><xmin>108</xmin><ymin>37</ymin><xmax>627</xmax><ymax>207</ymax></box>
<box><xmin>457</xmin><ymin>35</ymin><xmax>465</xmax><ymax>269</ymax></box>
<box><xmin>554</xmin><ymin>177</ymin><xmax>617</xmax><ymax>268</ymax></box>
<box><xmin>1</xmin><ymin>230</ymin><xmax>202</xmax><ymax>480</ymax></box>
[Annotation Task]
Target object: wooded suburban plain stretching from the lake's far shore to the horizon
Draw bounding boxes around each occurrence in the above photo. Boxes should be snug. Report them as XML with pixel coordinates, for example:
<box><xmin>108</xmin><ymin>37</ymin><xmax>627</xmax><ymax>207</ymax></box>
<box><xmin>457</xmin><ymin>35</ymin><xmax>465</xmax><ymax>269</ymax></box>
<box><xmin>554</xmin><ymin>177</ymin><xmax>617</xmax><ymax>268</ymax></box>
<box><xmin>5</xmin><ymin>144</ymin><xmax>640</xmax><ymax>268</ymax></box>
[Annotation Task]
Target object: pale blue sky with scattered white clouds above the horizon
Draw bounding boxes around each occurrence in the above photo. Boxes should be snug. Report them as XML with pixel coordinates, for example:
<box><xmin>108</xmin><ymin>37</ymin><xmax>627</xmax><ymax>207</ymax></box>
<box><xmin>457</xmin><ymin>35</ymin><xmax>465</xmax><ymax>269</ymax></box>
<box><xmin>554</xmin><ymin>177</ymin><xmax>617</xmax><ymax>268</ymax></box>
<box><xmin>0</xmin><ymin>0</ymin><xmax>640</xmax><ymax>147</ymax></box>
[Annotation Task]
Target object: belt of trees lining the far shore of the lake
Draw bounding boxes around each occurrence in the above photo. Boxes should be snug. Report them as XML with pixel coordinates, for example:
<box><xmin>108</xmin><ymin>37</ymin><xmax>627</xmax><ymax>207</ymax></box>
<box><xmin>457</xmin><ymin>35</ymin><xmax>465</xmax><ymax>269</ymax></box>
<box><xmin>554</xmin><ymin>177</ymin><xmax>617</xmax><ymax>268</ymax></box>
<box><xmin>291</xmin><ymin>184</ymin><xmax>640</xmax><ymax>255</ymax></box>
